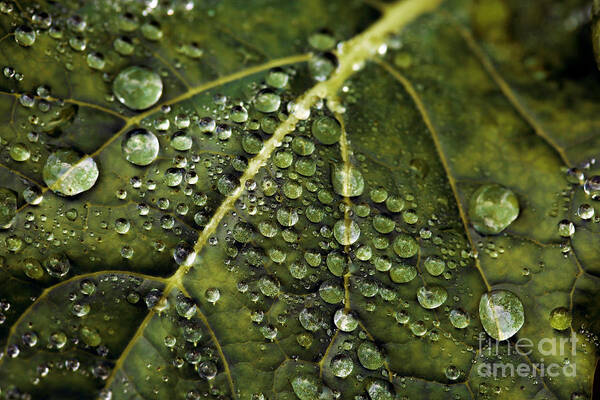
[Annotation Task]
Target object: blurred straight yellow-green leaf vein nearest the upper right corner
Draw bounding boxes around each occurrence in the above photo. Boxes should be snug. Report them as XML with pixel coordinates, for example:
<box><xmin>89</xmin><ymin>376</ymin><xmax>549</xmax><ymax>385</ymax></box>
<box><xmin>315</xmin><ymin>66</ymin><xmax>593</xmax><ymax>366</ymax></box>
<box><xmin>452</xmin><ymin>20</ymin><xmax>571</xmax><ymax>166</ymax></box>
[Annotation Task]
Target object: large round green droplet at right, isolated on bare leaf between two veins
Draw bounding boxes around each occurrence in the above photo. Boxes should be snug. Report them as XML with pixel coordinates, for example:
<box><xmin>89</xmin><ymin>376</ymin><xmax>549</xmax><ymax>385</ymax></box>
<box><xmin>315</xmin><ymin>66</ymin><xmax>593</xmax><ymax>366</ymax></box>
<box><xmin>469</xmin><ymin>184</ymin><xmax>519</xmax><ymax>235</ymax></box>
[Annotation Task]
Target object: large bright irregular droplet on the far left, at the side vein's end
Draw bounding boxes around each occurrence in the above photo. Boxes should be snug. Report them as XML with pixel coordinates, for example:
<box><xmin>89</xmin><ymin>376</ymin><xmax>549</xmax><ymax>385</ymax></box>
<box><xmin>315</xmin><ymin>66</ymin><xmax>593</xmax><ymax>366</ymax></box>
<box><xmin>43</xmin><ymin>150</ymin><xmax>99</xmax><ymax>196</ymax></box>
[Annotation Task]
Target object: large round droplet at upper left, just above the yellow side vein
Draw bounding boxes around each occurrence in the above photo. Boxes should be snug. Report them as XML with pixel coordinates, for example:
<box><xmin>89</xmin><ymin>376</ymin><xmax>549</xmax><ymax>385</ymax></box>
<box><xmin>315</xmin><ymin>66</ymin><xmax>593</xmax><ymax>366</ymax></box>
<box><xmin>113</xmin><ymin>66</ymin><xmax>163</xmax><ymax>110</ymax></box>
